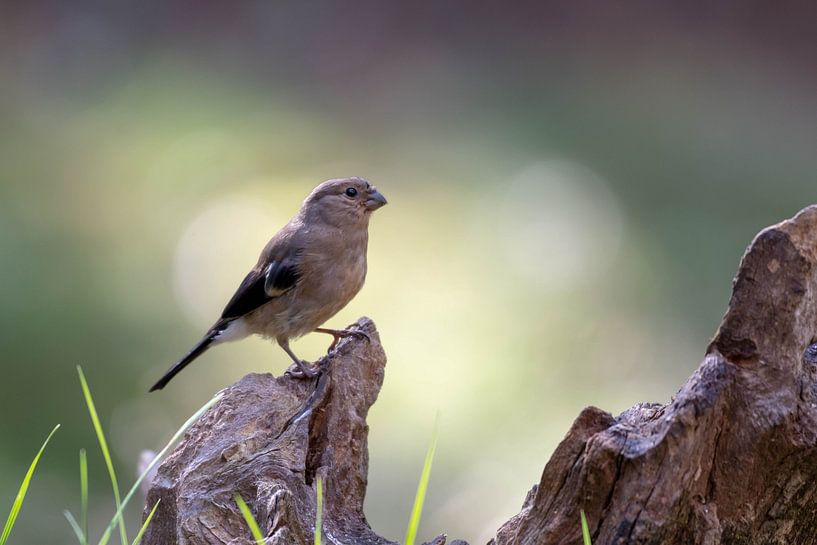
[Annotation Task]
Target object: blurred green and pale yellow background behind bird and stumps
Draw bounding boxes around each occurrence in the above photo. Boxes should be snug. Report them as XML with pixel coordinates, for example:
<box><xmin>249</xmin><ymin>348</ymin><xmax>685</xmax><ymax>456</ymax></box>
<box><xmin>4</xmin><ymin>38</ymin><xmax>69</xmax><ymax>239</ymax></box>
<box><xmin>0</xmin><ymin>0</ymin><xmax>817</xmax><ymax>544</ymax></box>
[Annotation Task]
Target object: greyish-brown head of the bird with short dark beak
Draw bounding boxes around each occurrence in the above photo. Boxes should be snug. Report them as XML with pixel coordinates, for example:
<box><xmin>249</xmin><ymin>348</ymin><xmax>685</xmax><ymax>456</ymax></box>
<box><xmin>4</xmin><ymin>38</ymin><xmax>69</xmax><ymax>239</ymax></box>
<box><xmin>301</xmin><ymin>174</ymin><xmax>386</xmax><ymax>227</ymax></box>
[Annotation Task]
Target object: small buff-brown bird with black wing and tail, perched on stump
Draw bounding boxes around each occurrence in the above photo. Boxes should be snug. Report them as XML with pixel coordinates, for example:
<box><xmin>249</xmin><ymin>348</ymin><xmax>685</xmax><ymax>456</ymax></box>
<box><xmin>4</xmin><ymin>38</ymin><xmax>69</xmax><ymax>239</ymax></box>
<box><xmin>150</xmin><ymin>177</ymin><xmax>387</xmax><ymax>392</ymax></box>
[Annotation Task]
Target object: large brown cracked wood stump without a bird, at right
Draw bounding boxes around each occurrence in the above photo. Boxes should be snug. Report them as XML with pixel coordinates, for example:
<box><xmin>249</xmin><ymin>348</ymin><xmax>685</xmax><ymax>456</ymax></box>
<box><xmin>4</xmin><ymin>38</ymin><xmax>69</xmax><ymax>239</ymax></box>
<box><xmin>493</xmin><ymin>206</ymin><xmax>817</xmax><ymax>545</ymax></box>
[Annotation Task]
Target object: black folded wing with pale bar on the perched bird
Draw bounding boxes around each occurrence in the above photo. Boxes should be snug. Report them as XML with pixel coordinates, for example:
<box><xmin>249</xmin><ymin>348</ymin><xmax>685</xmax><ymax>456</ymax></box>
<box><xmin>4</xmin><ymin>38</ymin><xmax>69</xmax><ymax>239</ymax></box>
<box><xmin>221</xmin><ymin>245</ymin><xmax>301</xmax><ymax>320</ymax></box>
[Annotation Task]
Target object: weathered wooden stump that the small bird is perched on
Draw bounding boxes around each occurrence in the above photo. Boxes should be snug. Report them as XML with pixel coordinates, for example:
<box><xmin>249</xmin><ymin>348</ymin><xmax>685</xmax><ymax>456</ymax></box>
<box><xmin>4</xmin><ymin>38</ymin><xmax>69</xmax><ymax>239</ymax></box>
<box><xmin>143</xmin><ymin>318</ymin><xmax>393</xmax><ymax>545</ymax></box>
